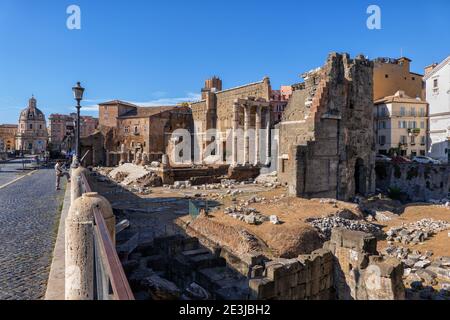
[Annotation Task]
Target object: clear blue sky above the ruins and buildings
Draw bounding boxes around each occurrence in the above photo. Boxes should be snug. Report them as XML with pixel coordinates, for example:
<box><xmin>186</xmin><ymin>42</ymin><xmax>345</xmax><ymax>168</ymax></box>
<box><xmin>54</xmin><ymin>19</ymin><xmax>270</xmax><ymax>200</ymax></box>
<box><xmin>0</xmin><ymin>0</ymin><xmax>450</xmax><ymax>123</ymax></box>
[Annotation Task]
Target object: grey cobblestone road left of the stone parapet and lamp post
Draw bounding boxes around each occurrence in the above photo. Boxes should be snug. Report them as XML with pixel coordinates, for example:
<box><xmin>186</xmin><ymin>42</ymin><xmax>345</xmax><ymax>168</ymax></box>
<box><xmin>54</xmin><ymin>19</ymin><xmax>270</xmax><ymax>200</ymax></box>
<box><xmin>0</xmin><ymin>163</ymin><xmax>66</xmax><ymax>300</ymax></box>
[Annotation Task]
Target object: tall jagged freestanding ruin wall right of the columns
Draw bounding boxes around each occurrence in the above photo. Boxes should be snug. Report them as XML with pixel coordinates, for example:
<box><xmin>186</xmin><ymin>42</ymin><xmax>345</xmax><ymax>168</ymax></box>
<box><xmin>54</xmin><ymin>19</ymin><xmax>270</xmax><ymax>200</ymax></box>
<box><xmin>278</xmin><ymin>53</ymin><xmax>375</xmax><ymax>200</ymax></box>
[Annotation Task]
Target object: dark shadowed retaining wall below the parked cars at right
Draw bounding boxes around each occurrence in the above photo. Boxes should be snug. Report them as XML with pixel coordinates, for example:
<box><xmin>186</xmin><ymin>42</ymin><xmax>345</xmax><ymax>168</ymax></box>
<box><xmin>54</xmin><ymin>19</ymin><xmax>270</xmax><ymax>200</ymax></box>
<box><xmin>375</xmin><ymin>162</ymin><xmax>450</xmax><ymax>202</ymax></box>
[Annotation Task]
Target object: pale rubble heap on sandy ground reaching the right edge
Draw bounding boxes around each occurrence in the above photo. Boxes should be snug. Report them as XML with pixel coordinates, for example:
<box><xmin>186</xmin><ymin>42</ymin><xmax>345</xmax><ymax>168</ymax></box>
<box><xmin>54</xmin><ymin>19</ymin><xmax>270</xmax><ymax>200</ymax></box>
<box><xmin>386</xmin><ymin>219</ymin><xmax>450</xmax><ymax>245</ymax></box>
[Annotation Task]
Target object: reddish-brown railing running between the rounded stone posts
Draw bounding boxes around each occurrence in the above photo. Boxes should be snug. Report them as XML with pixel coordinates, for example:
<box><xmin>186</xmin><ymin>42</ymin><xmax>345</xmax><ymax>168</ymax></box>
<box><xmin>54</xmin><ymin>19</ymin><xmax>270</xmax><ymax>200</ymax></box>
<box><xmin>81</xmin><ymin>174</ymin><xmax>134</xmax><ymax>300</ymax></box>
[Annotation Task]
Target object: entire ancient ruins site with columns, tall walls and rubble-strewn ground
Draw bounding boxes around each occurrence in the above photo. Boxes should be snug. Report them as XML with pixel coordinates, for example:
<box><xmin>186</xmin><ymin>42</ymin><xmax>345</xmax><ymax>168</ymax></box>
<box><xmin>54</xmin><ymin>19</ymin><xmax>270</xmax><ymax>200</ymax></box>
<box><xmin>50</xmin><ymin>53</ymin><xmax>450</xmax><ymax>301</ymax></box>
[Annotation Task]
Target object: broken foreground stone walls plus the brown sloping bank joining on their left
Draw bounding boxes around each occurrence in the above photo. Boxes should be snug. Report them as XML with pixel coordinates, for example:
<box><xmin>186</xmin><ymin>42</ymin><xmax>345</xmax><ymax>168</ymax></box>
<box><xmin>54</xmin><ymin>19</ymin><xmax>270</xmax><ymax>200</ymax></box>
<box><xmin>182</xmin><ymin>212</ymin><xmax>405</xmax><ymax>300</ymax></box>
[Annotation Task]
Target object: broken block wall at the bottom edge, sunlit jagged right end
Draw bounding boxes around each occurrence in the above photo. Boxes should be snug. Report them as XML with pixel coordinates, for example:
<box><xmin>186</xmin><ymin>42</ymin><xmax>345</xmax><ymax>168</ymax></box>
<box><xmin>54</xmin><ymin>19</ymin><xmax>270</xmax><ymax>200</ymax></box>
<box><xmin>249</xmin><ymin>229</ymin><xmax>405</xmax><ymax>300</ymax></box>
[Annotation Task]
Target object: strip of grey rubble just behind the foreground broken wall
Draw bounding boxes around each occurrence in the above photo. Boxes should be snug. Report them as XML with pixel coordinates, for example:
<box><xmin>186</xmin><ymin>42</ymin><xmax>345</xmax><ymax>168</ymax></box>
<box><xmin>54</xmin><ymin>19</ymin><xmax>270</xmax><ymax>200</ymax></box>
<box><xmin>306</xmin><ymin>215</ymin><xmax>384</xmax><ymax>239</ymax></box>
